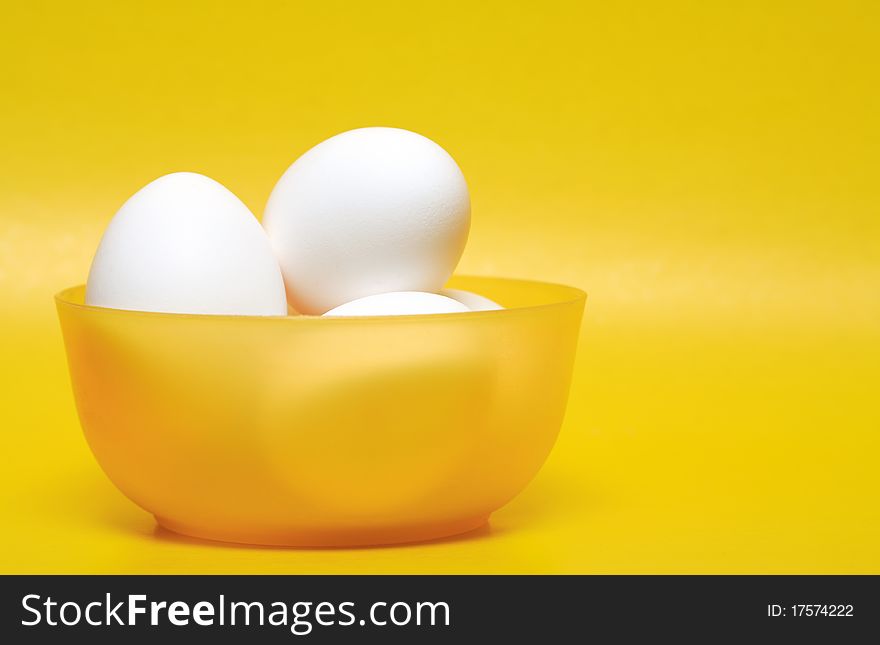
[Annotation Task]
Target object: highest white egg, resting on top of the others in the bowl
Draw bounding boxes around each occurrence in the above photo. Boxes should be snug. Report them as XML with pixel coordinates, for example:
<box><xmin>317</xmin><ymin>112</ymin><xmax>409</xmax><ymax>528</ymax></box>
<box><xmin>263</xmin><ymin>128</ymin><xmax>470</xmax><ymax>314</ymax></box>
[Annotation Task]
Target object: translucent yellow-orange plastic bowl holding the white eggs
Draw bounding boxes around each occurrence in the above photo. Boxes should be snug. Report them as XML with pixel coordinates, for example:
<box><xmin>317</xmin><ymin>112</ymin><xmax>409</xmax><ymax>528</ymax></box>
<box><xmin>55</xmin><ymin>277</ymin><xmax>586</xmax><ymax>546</ymax></box>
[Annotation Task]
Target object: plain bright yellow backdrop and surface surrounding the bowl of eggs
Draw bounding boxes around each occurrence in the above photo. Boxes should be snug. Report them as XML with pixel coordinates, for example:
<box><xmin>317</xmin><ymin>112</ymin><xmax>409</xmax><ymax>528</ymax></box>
<box><xmin>0</xmin><ymin>0</ymin><xmax>880</xmax><ymax>573</ymax></box>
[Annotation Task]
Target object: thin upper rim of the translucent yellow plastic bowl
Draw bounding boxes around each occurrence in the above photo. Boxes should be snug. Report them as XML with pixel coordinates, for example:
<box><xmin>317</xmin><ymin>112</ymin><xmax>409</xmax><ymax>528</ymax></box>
<box><xmin>54</xmin><ymin>274</ymin><xmax>588</xmax><ymax>324</ymax></box>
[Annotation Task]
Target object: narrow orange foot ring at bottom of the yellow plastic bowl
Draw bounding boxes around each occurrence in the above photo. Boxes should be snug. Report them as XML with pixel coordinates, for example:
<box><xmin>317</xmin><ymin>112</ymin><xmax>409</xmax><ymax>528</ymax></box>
<box><xmin>154</xmin><ymin>515</ymin><xmax>489</xmax><ymax>548</ymax></box>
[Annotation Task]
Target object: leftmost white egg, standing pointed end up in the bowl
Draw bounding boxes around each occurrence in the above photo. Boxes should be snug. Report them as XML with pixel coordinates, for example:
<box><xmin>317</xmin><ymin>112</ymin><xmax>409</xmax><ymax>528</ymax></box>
<box><xmin>86</xmin><ymin>172</ymin><xmax>287</xmax><ymax>316</ymax></box>
